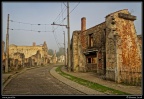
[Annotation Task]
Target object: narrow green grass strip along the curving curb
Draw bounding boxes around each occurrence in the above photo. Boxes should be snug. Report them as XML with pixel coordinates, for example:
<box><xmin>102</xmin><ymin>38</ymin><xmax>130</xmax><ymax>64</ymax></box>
<box><xmin>56</xmin><ymin>66</ymin><xmax>131</xmax><ymax>95</ymax></box>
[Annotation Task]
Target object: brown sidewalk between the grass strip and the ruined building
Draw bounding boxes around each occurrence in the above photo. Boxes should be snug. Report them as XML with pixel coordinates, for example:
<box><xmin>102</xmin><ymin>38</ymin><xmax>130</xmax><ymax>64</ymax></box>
<box><xmin>61</xmin><ymin>66</ymin><xmax>142</xmax><ymax>95</ymax></box>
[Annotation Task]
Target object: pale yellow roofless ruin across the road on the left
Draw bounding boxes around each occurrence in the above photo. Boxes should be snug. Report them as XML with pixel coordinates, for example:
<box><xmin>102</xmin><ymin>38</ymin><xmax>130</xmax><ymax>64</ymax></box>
<box><xmin>9</xmin><ymin>42</ymin><xmax>49</xmax><ymax>69</ymax></box>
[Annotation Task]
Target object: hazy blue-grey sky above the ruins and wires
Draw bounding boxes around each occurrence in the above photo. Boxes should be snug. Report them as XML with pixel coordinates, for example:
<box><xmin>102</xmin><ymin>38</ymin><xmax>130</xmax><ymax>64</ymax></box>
<box><xmin>2</xmin><ymin>1</ymin><xmax>142</xmax><ymax>51</ymax></box>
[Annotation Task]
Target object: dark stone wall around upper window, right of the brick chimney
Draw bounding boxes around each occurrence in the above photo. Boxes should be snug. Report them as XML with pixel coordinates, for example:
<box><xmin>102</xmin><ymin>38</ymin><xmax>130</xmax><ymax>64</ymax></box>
<box><xmin>85</xmin><ymin>22</ymin><xmax>106</xmax><ymax>74</ymax></box>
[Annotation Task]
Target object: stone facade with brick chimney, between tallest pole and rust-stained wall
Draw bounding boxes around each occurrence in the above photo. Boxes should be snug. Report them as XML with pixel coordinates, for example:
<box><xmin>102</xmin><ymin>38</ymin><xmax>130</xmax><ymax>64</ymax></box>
<box><xmin>71</xmin><ymin>18</ymin><xmax>105</xmax><ymax>73</ymax></box>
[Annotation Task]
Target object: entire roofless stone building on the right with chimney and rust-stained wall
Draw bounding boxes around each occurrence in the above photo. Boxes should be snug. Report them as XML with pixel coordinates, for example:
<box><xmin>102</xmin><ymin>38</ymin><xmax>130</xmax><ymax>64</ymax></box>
<box><xmin>70</xmin><ymin>9</ymin><xmax>142</xmax><ymax>85</ymax></box>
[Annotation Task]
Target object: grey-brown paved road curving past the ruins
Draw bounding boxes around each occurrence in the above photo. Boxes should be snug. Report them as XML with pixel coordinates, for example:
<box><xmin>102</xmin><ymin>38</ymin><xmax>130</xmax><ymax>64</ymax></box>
<box><xmin>3</xmin><ymin>65</ymin><xmax>84</xmax><ymax>95</ymax></box>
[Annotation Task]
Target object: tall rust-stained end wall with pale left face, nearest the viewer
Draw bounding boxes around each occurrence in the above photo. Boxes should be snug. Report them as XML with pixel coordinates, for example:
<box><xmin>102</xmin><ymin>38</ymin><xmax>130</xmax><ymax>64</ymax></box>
<box><xmin>106</xmin><ymin>9</ymin><xmax>142</xmax><ymax>85</ymax></box>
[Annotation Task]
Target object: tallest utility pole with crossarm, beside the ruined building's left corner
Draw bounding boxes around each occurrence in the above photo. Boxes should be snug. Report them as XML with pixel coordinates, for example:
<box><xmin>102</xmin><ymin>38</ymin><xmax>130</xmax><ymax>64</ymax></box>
<box><xmin>67</xmin><ymin>2</ymin><xmax>71</xmax><ymax>72</ymax></box>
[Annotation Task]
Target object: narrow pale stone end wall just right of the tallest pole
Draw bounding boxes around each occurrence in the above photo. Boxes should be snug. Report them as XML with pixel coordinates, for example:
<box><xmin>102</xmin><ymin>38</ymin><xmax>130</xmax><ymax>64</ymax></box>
<box><xmin>71</xmin><ymin>31</ymin><xmax>86</xmax><ymax>72</ymax></box>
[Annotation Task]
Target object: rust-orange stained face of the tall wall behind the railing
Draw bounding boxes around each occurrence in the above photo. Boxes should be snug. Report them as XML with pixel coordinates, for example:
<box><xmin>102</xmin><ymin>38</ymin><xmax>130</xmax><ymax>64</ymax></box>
<box><xmin>116</xmin><ymin>11</ymin><xmax>142</xmax><ymax>85</ymax></box>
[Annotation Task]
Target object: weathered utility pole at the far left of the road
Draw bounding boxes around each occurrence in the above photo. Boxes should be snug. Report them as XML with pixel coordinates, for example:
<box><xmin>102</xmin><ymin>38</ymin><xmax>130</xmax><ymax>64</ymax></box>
<box><xmin>5</xmin><ymin>14</ymin><xmax>9</xmax><ymax>73</ymax></box>
